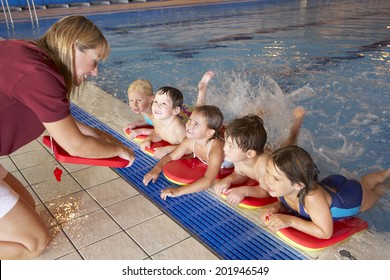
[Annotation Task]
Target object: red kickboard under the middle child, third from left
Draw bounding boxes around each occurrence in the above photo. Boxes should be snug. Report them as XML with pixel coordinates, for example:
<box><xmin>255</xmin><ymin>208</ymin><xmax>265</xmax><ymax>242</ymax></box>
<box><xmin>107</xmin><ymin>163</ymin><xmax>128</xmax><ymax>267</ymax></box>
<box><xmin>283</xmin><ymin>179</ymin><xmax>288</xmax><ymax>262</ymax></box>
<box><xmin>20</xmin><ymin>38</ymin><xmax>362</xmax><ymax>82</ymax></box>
<box><xmin>163</xmin><ymin>158</ymin><xmax>234</xmax><ymax>185</ymax></box>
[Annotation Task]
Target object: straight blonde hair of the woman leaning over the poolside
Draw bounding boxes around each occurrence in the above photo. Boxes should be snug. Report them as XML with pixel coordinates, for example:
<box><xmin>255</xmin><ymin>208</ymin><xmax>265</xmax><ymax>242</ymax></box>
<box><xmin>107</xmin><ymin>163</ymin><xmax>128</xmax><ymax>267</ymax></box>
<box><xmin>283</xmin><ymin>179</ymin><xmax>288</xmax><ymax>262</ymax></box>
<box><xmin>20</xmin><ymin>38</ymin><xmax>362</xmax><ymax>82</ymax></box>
<box><xmin>36</xmin><ymin>15</ymin><xmax>110</xmax><ymax>98</ymax></box>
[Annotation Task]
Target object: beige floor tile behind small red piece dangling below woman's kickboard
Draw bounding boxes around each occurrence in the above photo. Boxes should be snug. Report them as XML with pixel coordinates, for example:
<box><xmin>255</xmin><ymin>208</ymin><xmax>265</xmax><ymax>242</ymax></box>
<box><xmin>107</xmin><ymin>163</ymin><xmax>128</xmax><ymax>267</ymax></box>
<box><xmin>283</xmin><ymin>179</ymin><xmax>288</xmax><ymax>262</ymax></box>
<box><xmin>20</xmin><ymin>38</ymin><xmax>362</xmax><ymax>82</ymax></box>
<box><xmin>21</xmin><ymin>159</ymin><xmax>67</xmax><ymax>185</ymax></box>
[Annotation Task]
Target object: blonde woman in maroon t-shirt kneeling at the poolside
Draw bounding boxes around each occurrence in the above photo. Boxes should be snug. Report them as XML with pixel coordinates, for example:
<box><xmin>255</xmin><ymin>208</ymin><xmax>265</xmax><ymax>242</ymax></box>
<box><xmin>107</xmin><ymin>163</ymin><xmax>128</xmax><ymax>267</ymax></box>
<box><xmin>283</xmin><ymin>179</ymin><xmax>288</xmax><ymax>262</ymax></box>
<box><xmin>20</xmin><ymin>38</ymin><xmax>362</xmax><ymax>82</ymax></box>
<box><xmin>0</xmin><ymin>15</ymin><xmax>134</xmax><ymax>260</ymax></box>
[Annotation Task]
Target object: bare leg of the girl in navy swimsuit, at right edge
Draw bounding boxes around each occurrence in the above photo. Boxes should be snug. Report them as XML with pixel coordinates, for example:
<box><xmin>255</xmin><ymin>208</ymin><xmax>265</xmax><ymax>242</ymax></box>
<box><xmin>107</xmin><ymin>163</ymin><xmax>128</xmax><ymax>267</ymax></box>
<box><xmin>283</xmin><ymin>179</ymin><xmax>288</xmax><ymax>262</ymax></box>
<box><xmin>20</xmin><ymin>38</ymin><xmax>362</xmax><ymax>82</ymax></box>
<box><xmin>360</xmin><ymin>169</ymin><xmax>390</xmax><ymax>212</ymax></box>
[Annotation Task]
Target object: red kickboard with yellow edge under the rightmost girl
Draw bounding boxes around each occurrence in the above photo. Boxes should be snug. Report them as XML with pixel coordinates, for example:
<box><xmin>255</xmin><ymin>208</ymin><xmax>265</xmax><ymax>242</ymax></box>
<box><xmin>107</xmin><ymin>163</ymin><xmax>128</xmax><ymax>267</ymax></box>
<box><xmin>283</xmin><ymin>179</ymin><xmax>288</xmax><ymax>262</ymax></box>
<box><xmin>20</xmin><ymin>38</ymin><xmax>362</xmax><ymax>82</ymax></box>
<box><xmin>277</xmin><ymin>217</ymin><xmax>368</xmax><ymax>251</ymax></box>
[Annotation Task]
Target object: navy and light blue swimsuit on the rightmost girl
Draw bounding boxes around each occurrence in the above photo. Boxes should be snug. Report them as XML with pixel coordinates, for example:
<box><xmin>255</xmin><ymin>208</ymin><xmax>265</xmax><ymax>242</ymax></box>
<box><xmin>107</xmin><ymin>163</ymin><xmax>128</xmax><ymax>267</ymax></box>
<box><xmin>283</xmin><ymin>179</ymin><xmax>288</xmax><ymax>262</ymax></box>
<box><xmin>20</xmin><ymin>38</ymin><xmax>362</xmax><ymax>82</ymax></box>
<box><xmin>279</xmin><ymin>175</ymin><xmax>363</xmax><ymax>220</ymax></box>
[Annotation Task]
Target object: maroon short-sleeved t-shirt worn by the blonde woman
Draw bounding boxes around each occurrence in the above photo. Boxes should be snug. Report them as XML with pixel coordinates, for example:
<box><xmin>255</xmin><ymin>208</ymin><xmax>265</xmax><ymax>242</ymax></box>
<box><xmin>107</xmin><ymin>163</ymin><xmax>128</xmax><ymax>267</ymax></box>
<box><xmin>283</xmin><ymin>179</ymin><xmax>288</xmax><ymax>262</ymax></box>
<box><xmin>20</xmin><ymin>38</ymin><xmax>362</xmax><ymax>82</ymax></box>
<box><xmin>0</xmin><ymin>40</ymin><xmax>70</xmax><ymax>155</ymax></box>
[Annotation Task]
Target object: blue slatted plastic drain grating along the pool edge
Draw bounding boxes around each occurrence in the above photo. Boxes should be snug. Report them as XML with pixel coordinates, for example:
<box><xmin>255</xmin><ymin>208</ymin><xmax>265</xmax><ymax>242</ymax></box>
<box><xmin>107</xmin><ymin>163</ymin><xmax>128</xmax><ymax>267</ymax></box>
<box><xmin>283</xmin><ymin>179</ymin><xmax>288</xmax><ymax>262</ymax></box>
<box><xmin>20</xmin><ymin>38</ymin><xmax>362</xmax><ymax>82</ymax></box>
<box><xmin>71</xmin><ymin>104</ymin><xmax>307</xmax><ymax>260</ymax></box>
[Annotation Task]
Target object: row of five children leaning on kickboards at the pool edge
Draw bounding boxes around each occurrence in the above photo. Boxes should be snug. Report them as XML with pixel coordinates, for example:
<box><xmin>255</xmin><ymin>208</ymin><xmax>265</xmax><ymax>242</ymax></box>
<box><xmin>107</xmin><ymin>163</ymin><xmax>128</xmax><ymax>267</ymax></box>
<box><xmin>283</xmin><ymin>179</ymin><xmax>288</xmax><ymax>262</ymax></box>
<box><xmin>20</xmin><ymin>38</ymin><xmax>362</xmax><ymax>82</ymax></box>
<box><xmin>124</xmin><ymin>71</ymin><xmax>390</xmax><ymax>239</ymax></box>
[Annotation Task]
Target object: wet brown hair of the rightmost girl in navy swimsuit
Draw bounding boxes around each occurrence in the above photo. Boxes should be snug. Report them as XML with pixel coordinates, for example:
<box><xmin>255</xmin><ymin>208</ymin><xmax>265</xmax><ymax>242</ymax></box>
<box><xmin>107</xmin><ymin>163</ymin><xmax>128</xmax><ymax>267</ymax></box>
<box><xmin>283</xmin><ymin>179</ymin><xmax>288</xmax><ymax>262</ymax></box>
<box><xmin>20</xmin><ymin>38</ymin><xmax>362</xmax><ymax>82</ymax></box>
<box><xmin>271</xmin><ymin>146</ymin><xmax>318</xmax><ymax>205</ymax></box>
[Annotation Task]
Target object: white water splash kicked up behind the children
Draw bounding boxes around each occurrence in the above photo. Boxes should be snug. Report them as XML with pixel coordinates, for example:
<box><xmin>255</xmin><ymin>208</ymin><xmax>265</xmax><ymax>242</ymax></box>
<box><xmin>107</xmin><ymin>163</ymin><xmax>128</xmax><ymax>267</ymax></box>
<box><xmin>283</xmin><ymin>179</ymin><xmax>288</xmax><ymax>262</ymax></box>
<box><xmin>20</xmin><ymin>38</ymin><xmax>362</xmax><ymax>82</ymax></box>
<box><xmin>207</xmin><ymin>72</ymin><xmax>305</xmax><ymax>151</ymax></box>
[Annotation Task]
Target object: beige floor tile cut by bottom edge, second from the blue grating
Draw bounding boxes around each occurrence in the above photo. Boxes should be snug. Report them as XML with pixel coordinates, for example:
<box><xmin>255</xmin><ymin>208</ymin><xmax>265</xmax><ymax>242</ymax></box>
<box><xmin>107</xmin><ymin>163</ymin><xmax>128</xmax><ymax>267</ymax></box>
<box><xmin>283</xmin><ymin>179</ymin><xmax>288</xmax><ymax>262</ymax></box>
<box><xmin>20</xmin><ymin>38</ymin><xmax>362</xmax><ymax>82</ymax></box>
<box><xmin>80</xmin><ymin>232</ymin><xmax>148</xmax><ymax>260</ymax></box>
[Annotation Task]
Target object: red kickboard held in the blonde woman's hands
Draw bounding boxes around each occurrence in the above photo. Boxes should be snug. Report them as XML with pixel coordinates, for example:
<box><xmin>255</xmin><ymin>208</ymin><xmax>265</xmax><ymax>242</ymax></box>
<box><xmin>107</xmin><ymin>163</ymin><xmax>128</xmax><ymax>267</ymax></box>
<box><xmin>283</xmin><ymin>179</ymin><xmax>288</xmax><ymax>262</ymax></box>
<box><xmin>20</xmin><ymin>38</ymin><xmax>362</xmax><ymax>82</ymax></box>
<box><xmin>43</xmin><ymin>135</ymin><xmax>129</xmax><ymax>168</ymax></box>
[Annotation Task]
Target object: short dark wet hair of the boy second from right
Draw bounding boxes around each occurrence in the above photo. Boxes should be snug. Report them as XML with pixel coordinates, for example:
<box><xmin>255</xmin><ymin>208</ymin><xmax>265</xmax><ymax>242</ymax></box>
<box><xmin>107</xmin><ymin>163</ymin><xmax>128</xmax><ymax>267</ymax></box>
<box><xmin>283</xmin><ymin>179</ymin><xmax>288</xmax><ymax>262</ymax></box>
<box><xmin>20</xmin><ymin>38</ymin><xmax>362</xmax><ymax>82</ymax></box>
<box><xmin>225</xmin><ymin>114</ymin><xmax>267</xmax><ymax>155</ymax></box>
